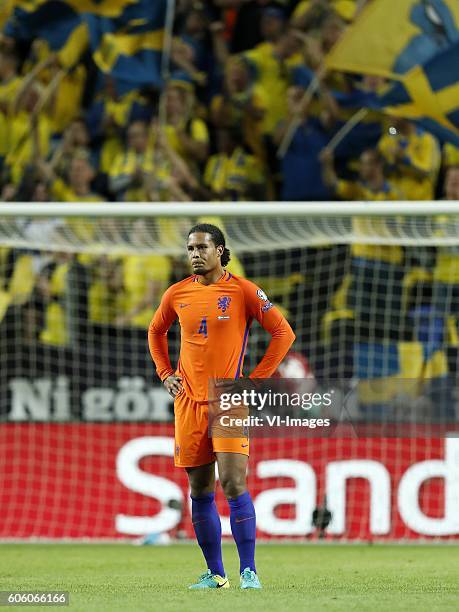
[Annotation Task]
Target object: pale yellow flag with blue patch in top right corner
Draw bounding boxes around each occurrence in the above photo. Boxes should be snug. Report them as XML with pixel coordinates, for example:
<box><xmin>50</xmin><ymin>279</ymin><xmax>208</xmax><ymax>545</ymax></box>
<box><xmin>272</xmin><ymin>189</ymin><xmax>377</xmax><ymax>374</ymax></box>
<box><xmin>326</xmin><ymin>0</ymin><xmax>459</xmax><ymax>79</ymax></box>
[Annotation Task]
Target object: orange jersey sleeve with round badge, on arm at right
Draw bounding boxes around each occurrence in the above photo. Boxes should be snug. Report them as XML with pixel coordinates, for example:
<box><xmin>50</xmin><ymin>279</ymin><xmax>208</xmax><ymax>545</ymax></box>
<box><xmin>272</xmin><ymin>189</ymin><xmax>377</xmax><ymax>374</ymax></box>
<box><xmin>242</xmin><ymin>281</ymin><xmax>295</xmax><ymax>378</ymax></box>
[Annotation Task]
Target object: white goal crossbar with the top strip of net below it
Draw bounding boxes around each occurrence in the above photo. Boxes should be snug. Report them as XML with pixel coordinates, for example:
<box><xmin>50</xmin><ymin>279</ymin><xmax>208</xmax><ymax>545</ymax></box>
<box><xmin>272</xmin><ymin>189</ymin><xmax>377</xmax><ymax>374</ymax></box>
<box><xmin>0</xmin><ymin>201</ymin><xmax>459</xmax><ymax>255</ymax></box>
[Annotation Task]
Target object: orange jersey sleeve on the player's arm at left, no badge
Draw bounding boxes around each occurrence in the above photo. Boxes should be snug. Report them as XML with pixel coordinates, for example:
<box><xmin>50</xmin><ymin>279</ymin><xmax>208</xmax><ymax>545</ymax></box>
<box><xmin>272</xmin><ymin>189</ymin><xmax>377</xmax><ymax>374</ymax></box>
<box><xmin>148</xmin><ymin>287</ymin><xmax>177</xmax><ymax>381</ymax></box>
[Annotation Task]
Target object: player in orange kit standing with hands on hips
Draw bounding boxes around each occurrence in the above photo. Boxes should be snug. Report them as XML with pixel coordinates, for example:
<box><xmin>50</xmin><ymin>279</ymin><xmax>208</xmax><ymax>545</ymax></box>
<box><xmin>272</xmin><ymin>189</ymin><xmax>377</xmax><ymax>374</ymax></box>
<box><xmin>148</xmin><ymin>223</ymin><xmax>295</xmax><ymax>589</ymax></box>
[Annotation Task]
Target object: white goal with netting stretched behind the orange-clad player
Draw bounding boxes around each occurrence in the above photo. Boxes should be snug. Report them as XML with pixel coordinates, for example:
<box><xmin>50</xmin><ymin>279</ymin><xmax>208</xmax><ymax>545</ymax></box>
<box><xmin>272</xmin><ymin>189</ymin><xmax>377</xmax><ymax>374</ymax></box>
<box><xmin>0</xmin><ymin>202</ymin><xmax>459</xmax><ymax>541</ymax></box>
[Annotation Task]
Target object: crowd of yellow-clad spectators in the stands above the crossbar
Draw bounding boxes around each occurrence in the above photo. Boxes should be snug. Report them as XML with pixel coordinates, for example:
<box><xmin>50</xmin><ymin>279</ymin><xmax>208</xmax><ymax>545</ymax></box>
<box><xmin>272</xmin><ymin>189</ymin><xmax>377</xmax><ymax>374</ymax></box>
<box><xmin>0</xmin><ymin>0</ymin><xmax>459</xmax><ymax>207</ymax></box>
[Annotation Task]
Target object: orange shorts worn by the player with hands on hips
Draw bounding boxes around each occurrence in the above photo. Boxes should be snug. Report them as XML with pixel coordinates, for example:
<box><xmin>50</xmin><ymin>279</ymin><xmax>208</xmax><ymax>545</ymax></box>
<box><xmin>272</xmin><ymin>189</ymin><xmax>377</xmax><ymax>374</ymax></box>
<box><xmin>174</xmin><ymin>392</ymin><xmax>250</xmax><ymax>467</ymax></box>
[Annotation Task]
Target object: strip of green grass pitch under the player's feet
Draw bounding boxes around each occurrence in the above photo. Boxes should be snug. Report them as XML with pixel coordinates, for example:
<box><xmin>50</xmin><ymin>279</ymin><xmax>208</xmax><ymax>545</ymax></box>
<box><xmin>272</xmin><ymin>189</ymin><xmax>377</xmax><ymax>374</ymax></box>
<box><xmin>0</xmin><ymin>544</ymin><xmax>459</xmax><ymax>612</ymax></box>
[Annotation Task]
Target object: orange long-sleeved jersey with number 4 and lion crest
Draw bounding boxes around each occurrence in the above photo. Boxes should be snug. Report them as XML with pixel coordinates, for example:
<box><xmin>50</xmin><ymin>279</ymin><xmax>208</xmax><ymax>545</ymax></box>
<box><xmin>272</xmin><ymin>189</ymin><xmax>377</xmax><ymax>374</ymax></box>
<box><xmin>148</xmin><ymin>271</ymin><xmax>295</xmax><ymax>401</ymax></box>
